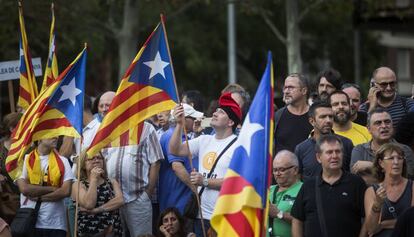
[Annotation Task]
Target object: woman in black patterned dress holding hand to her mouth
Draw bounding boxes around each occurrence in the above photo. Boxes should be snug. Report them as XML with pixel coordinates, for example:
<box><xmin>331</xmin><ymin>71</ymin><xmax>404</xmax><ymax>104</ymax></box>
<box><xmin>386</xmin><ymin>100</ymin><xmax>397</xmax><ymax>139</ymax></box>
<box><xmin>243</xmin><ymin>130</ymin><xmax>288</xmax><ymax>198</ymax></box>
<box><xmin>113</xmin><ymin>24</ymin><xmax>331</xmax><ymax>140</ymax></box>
<box><xmin>72</xmin><ymin>152</ymin><xmax>124</xmax><ymax>237</ymax></box>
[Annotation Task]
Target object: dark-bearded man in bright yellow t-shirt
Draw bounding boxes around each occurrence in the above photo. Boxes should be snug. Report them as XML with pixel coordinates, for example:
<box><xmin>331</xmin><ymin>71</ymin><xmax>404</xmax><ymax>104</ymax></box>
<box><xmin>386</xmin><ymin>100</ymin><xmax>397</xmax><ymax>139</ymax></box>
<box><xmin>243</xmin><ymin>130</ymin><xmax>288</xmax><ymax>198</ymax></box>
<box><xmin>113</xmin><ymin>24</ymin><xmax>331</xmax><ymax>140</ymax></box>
<box><xmin>328</xmin><ymin>91</ymin><xmax>371</xmax><ymax>146</ymax></box>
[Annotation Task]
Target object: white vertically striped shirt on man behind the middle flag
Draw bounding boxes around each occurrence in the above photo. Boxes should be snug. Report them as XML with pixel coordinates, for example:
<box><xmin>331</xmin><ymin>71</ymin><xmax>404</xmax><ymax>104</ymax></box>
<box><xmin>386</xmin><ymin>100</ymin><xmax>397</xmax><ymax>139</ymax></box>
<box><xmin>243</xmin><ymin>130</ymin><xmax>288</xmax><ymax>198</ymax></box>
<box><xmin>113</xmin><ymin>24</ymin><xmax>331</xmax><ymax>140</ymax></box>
<box><xmin>102</xmin><ymin>122</ymin><xmax>164</xmax><ymax>203</ymax></box>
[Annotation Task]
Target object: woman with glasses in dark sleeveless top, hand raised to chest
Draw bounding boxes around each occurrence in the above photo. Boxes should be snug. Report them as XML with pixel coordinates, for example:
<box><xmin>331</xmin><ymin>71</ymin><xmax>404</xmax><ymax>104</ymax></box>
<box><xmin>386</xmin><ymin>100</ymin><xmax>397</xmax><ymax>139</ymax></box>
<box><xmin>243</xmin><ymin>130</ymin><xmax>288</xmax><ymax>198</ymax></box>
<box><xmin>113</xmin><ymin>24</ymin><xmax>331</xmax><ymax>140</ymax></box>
<box><xmin>365</xmin><ymin>143</ymin><xmax>414</xmax><ymax>237</ymax></box>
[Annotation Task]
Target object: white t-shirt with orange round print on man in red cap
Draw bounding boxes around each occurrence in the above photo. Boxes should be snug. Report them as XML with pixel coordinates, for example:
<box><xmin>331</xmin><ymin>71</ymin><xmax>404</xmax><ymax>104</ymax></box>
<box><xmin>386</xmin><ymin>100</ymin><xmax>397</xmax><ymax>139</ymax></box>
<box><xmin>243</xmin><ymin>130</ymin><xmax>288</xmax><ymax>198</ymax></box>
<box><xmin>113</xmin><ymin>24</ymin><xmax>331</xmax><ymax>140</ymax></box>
<box><xmin>188</xmin><ymin>135</ymin><xmax>236</xmax><ymax>220</ymax></box>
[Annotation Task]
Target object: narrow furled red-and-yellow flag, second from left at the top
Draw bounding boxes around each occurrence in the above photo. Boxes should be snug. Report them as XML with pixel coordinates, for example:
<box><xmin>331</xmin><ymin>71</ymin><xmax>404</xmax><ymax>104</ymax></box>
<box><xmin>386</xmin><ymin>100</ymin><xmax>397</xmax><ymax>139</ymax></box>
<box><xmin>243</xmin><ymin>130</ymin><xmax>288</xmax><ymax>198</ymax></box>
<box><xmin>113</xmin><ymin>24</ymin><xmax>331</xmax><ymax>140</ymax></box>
<box><xmin>41</xmin><ymin>3</ymin><xmax>59</xmax><ymax>91</ymax></box>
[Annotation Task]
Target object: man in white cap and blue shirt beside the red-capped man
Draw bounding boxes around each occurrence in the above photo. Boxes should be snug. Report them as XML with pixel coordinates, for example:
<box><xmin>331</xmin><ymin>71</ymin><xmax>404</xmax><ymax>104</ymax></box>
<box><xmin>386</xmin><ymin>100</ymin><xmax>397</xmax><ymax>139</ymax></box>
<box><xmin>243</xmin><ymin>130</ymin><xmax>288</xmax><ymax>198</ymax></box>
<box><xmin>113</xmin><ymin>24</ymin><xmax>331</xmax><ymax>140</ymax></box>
<box><xmin>158</xmin><ymin>104</ymin><xmax>204</xmax><ymax>214</ymax></box>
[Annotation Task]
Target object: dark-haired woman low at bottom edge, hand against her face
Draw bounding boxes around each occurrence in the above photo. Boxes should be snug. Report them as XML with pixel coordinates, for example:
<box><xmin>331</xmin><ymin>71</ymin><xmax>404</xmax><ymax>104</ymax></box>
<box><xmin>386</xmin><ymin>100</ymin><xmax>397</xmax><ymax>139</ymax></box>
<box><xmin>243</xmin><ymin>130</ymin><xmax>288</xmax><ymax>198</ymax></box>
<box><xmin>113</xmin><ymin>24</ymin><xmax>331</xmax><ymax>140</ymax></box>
<box><xmin>157</xmin><ymin>207</ymin><xmax>196</xmax><ymax>237</ymax></box>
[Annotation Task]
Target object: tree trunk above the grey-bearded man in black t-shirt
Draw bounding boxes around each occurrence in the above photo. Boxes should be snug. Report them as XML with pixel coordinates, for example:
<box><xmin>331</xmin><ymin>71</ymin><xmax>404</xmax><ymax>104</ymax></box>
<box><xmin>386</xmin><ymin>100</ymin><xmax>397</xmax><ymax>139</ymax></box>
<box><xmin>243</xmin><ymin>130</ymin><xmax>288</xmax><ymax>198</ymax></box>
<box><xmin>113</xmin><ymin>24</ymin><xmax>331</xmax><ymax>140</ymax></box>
<box><xmin>286</xmin><ymin>0</ymin><xmax>302</xmax><ymax>73</ymax></box>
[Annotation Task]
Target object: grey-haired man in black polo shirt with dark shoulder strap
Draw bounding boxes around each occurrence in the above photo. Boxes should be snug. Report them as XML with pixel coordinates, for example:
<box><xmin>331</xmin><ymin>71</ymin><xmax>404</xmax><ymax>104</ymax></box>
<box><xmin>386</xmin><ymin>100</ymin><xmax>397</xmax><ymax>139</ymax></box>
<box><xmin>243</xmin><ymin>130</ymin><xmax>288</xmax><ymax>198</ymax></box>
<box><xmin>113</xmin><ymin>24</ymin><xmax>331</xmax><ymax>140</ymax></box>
<box><xmin>291</xmin><ymin>135</ymin><xmax>366</xmax><ymax>237</ymax></box>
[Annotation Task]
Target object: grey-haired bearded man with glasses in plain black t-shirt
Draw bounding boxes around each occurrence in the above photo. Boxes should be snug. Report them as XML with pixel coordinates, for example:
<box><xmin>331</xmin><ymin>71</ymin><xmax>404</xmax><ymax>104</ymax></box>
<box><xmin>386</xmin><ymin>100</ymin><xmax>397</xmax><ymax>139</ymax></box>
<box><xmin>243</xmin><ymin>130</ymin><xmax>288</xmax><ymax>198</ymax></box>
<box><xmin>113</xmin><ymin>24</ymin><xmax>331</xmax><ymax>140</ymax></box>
<box><xmin>275</xmin><ymin>73</ymin><xmax>312</xmax><ymax>153</ymax></box>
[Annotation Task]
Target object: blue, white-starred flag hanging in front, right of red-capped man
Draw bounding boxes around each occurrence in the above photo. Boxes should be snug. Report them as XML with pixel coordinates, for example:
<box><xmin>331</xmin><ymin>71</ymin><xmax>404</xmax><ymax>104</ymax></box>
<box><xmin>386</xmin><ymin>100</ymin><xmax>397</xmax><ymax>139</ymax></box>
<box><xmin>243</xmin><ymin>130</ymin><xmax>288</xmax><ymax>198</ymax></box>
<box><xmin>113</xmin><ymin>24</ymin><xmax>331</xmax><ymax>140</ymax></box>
<box><xmin>211</xmin><ymin>52</ymin><xmax>273</xmax><ymax>237</ymax></box>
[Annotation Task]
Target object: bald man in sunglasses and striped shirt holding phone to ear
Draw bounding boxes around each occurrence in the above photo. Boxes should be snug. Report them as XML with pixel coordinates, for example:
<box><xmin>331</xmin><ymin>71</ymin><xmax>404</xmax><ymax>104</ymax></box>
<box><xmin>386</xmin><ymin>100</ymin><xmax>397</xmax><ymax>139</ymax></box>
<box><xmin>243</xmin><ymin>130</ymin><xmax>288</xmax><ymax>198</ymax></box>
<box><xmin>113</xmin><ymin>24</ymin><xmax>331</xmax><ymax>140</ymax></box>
<box><xmin>361</xmin><ymin>67</ymin><xmax>414</xmax><ymax>128</ymax></box>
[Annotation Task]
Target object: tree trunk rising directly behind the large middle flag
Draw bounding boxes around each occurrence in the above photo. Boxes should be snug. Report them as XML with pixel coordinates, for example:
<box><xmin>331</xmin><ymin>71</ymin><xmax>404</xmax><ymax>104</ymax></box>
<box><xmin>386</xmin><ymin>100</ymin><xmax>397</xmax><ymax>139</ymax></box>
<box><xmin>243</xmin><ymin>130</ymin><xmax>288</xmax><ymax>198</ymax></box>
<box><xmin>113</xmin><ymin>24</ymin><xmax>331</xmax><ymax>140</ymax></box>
<box><xmin>117</xmin><ymin>0</ymin><xmax>138</xmax><ymax>80</ymax></box>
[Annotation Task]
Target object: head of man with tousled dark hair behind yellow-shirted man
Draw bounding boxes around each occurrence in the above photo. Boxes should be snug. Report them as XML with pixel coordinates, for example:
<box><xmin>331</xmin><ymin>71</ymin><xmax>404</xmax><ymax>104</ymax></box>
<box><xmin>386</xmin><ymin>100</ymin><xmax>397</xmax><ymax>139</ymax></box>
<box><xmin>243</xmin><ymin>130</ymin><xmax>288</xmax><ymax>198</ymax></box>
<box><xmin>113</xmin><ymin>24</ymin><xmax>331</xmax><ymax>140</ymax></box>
<box><xmin>317</xmin><ymin>68</ymin><xmax>342</xmax><ymax>101</ymax></box>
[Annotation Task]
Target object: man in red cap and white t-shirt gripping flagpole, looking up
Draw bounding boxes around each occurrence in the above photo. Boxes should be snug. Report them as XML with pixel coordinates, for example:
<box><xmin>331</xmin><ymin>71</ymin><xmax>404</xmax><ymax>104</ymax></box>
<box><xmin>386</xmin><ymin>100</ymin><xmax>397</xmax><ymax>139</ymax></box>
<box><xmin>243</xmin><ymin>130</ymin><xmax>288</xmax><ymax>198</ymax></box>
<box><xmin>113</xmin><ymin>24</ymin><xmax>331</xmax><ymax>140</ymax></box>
<box><xmin>169</xmin><ymin>93</ymin><xmax>242</xmax><ymax>236</ymax></box>
